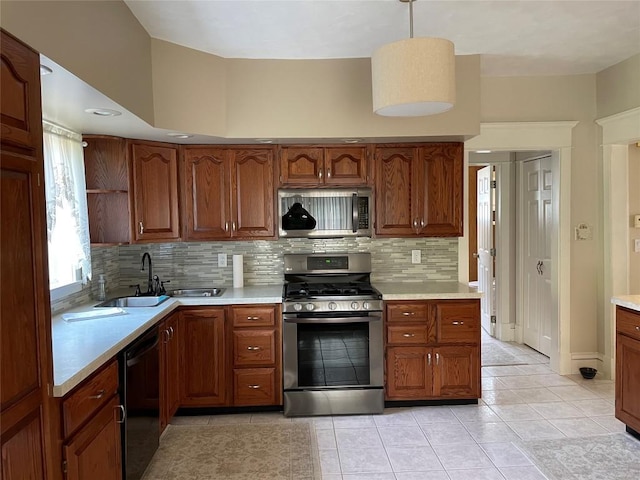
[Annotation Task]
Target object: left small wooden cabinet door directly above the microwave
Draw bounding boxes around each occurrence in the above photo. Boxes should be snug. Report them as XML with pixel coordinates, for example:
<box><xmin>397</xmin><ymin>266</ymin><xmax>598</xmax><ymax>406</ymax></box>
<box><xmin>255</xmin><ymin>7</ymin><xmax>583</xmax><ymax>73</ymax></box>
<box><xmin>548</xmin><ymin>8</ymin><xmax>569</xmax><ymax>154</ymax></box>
<box><xmin>280</xmin><ymin>147</ymin><xmax>324</xmax><ymax>185</ymax></box>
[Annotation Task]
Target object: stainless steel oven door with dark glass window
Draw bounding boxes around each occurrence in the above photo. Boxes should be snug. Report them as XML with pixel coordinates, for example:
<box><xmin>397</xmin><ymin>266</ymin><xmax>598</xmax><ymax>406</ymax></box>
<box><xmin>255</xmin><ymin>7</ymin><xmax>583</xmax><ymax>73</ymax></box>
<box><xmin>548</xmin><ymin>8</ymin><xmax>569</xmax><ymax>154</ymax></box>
<box><xmin>283</xmin><ymin>312</ymin><xmax>384</xmax><ymax>391</ymax></box>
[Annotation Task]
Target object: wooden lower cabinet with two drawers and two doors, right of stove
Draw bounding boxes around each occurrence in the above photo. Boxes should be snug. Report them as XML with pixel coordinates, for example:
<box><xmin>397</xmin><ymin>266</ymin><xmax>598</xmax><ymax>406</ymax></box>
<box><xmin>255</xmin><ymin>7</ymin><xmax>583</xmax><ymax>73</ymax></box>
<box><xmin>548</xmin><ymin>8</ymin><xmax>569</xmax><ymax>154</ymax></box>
<box><xmin>385</xmin><ymin>300</ymin><xmax>481</xmax><ymax>400</ymax></box>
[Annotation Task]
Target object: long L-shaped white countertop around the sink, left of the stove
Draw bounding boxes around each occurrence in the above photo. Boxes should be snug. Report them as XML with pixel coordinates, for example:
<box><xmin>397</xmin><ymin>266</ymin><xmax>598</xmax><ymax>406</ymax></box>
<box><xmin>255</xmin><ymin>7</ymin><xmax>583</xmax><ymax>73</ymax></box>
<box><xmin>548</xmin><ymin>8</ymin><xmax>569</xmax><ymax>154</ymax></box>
<box><xmin>51</xmin><ymin>285</ymin><xmax>282</xmax><ymax>397</ymax></box>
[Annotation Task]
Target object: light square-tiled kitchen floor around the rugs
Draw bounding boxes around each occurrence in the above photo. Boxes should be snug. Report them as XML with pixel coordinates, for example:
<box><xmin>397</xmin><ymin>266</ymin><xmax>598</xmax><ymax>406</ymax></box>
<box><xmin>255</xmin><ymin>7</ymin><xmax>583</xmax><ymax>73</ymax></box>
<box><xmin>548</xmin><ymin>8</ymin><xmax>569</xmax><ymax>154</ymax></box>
<box><xmin>169</xmin><ymin>335</ymin><xmax>624</xmax><ymax>480</ymax></box>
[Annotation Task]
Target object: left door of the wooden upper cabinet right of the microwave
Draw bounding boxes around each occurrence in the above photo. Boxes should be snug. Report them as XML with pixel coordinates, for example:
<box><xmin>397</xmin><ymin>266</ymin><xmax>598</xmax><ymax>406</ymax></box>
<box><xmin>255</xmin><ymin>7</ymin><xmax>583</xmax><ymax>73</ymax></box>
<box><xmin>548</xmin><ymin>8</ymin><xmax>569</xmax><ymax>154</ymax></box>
<box><xmin>375</xmin><ymin>147</ymin><xmax>417</xmax><ymax>237</ymax></box>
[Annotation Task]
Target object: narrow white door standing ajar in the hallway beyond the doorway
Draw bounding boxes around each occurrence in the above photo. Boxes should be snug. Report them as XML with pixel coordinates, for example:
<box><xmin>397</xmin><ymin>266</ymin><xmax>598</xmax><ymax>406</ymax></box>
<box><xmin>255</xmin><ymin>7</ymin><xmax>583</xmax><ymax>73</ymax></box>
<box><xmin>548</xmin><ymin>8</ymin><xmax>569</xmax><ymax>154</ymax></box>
<box><xmin>477</xmin><ymin>167</ymin><xmax>495</xmax><ymax>336</ymax></box>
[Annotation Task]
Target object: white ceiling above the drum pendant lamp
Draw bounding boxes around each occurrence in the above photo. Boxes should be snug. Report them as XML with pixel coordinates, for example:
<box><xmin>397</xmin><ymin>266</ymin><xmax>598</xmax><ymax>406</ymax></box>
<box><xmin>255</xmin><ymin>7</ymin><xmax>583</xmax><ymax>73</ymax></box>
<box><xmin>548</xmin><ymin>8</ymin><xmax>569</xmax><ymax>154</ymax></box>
<box><xmin>125</xmin><ymin>0</ymin><xmax>640</xmax><ymax>76</ymax></box>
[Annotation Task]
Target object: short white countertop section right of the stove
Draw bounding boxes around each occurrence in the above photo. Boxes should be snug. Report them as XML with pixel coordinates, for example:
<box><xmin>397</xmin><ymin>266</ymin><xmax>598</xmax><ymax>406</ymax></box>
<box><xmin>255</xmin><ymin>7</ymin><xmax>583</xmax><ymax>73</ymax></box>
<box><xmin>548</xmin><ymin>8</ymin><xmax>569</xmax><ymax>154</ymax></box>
<box><xmin>373</xmin><ymin>282</ymin><xmax>482</xmax><ymax>300</ymax></box>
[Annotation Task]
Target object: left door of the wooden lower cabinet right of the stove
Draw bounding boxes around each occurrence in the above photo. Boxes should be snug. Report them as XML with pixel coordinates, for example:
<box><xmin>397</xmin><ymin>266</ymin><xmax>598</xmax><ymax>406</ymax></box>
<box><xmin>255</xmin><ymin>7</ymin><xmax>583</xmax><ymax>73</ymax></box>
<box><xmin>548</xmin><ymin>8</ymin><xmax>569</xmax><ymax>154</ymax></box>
<box><xmin>386</xmin><ymin>347</ymin><xmax>432</xmax><ymax>400</ymax></box>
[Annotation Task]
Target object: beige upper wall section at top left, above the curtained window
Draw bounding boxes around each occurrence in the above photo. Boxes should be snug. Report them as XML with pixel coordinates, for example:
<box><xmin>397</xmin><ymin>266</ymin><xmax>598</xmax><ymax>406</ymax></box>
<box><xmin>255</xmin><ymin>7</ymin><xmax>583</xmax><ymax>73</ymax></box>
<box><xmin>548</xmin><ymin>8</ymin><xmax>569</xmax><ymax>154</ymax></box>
<box><xmin>0</xmin><ymin>0</ymin><xmax>153</xmax><ymax>124</ymax></box>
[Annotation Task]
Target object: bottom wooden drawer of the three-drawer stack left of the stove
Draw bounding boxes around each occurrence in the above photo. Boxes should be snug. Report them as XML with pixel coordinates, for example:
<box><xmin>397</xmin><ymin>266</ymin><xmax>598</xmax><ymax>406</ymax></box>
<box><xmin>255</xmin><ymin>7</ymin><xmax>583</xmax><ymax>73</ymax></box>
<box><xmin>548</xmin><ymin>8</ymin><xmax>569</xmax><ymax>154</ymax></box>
<box><xmin>233</xmin><ymin>368</ymin><xmax>277</xmax><ymax>405</ymax></box>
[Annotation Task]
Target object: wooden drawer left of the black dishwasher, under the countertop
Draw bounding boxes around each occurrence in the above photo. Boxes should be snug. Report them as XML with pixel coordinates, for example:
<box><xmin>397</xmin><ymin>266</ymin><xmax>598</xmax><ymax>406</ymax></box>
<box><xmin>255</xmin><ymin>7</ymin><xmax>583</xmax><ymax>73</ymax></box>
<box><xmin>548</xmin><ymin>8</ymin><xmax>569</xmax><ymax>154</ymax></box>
<box><xmin>62</xmin><ymin>361</ymin><xmax>118</xmax><ymax>438</ymax></box>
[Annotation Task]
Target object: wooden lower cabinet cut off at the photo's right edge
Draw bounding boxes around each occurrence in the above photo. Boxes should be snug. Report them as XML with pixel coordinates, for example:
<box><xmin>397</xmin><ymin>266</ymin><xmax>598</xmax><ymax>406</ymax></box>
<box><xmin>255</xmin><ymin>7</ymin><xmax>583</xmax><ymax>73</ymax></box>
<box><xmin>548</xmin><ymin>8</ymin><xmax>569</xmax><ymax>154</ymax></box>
<box><xmin>616</xmin><ymin>307</ymin><xmax>640</xmax><ymax>433</ymax></box>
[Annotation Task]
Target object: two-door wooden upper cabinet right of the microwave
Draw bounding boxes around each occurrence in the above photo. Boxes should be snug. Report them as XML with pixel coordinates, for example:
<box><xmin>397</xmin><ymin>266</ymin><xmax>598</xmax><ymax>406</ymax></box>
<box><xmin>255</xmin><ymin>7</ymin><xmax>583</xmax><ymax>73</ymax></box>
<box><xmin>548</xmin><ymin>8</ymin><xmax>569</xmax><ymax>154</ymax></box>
<box><xmin>375</xmin><ymin>143</ymin><xmax>463</xmax><ymax>237</ymax></box>
